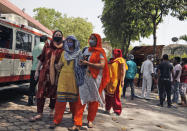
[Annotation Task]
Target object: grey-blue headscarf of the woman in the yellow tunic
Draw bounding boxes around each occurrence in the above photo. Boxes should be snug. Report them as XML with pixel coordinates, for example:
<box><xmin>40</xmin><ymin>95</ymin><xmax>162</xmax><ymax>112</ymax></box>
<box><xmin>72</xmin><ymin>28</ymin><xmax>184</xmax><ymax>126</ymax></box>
<box><xmin>64</xmin><ymin>36</ymin><xmax>86</xmax><ymax>86</ymax></box>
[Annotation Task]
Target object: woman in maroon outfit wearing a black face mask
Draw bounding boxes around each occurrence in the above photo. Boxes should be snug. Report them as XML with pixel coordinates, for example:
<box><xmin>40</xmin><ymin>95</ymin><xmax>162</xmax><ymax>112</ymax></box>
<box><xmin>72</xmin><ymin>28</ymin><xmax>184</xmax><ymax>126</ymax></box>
<box><xmin>30</xmin><ymin>30</ymin><xmax>63</xmax><ymax>122</ymax></box>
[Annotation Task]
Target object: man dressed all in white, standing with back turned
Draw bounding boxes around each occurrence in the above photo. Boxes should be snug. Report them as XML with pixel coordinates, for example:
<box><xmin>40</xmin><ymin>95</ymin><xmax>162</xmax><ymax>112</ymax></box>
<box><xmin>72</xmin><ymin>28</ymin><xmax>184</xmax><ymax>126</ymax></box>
<box><xmin>141</xmin><ymin>55</ymin><xmax>154</xmax><ymax>100</ymax></box>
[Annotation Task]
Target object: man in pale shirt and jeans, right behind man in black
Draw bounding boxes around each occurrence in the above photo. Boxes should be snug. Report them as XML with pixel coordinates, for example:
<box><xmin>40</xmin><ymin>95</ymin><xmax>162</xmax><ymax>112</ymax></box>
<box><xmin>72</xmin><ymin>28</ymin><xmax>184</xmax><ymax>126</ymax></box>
<box><xmin>172</xmin><ymin>57</ymin><xmax>182</xmax><ymax>103</ymax></box>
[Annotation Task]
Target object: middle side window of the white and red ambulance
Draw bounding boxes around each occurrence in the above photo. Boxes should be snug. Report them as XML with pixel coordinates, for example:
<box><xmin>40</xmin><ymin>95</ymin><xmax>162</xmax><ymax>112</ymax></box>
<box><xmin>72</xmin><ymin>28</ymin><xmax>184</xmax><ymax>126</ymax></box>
<box><xmin>16</xmin><ymin>31</ymin><xmax>32</xmax><ymax>52</ymax></box>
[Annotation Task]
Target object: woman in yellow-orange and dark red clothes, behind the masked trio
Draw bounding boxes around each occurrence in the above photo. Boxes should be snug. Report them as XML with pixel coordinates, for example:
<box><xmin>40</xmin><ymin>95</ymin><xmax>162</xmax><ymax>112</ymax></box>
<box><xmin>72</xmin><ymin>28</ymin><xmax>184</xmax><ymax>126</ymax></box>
<box><xmin>105</xmin><ymin>49</ymin><xmax>128</xmax><ymax>115</ymax></box>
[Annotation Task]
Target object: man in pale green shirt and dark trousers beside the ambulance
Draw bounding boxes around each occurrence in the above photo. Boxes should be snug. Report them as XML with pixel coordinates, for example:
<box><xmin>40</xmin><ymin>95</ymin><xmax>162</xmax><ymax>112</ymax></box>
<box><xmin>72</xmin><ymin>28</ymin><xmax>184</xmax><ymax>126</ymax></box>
<box><xmin>27</xmin><ymin>35</ymin><xmax>47</xmax><ymax>106</ymax></box>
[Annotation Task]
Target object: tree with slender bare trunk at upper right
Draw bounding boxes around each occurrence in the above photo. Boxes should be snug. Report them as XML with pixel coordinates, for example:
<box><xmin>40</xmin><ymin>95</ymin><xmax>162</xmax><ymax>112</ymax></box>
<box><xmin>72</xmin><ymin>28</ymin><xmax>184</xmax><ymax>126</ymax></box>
<box><xmin>135</xmin><ymin>0</ymin><xmax>187</xmax><ymax>57</ymax></box>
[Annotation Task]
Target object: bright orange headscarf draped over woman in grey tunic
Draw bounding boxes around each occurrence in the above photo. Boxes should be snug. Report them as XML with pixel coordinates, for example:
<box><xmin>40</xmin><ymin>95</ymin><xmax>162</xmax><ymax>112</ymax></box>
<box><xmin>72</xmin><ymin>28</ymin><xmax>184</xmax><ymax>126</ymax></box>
<box><xmin>88</xmin><ymin>33</ymin><xmax>110</xmax><ymax>93</ymax></box>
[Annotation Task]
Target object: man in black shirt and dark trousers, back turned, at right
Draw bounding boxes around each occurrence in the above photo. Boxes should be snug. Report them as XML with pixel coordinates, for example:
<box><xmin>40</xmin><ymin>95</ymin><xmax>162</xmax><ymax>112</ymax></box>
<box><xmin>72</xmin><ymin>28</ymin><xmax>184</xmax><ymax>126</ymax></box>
<box><xmin>158</xmin><ymin>54</ymin><xmax>173</xmax><ymax>108</ymax></box>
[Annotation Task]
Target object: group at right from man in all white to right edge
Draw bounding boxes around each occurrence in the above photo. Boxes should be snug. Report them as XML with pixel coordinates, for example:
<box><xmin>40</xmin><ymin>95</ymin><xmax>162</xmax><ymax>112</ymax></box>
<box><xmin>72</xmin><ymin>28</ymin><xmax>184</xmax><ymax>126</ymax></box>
<box><xmin>141</xmin><ymin>54</ymin><xmax>187</xmax><ymax>108</ymax></box>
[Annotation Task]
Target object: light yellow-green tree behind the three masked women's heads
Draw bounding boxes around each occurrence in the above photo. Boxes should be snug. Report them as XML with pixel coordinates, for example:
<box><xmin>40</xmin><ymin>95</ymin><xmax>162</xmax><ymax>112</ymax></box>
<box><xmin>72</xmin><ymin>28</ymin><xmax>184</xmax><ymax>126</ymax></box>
<box><xmin>33</xmin><ymin>8</ymin><xmax>93</xmax><ymax>47</ymax></box>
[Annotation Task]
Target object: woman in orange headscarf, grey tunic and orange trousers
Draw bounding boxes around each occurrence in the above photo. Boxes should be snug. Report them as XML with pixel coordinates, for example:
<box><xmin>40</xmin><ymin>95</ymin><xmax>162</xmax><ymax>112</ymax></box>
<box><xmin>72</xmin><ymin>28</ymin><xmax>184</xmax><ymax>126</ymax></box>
<box><xmin>70</xmin><ymin>34</ymin><xmax>109</xmax><ymax>131</ymax></box>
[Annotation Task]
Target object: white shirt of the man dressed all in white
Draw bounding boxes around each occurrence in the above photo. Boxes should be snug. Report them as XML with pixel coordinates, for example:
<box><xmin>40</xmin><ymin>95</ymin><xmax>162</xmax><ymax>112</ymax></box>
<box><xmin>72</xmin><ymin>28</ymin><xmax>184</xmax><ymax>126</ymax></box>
<box><xmin>141</xmin><ymin>59</ymin><xmax>154</xmax><ymax>78</ymax></box>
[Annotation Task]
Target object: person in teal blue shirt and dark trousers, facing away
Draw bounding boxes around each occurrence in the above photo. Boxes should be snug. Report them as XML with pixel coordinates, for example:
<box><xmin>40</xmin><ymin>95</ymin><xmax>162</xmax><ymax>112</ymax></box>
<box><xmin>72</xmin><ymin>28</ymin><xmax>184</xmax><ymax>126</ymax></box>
<box><xmin>123</xmin><ymin>54</ymin><xmax>137</xmax><ymax>100</ymax></box>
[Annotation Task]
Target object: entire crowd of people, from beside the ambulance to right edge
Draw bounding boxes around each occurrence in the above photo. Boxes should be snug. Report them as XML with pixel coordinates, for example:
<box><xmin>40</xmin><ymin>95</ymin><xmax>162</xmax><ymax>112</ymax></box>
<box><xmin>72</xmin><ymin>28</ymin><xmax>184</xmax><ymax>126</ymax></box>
<box><xmin>28</xmin><ymin>30</ymin><xmax>187</xmax><ymax>131</ymax></box>
